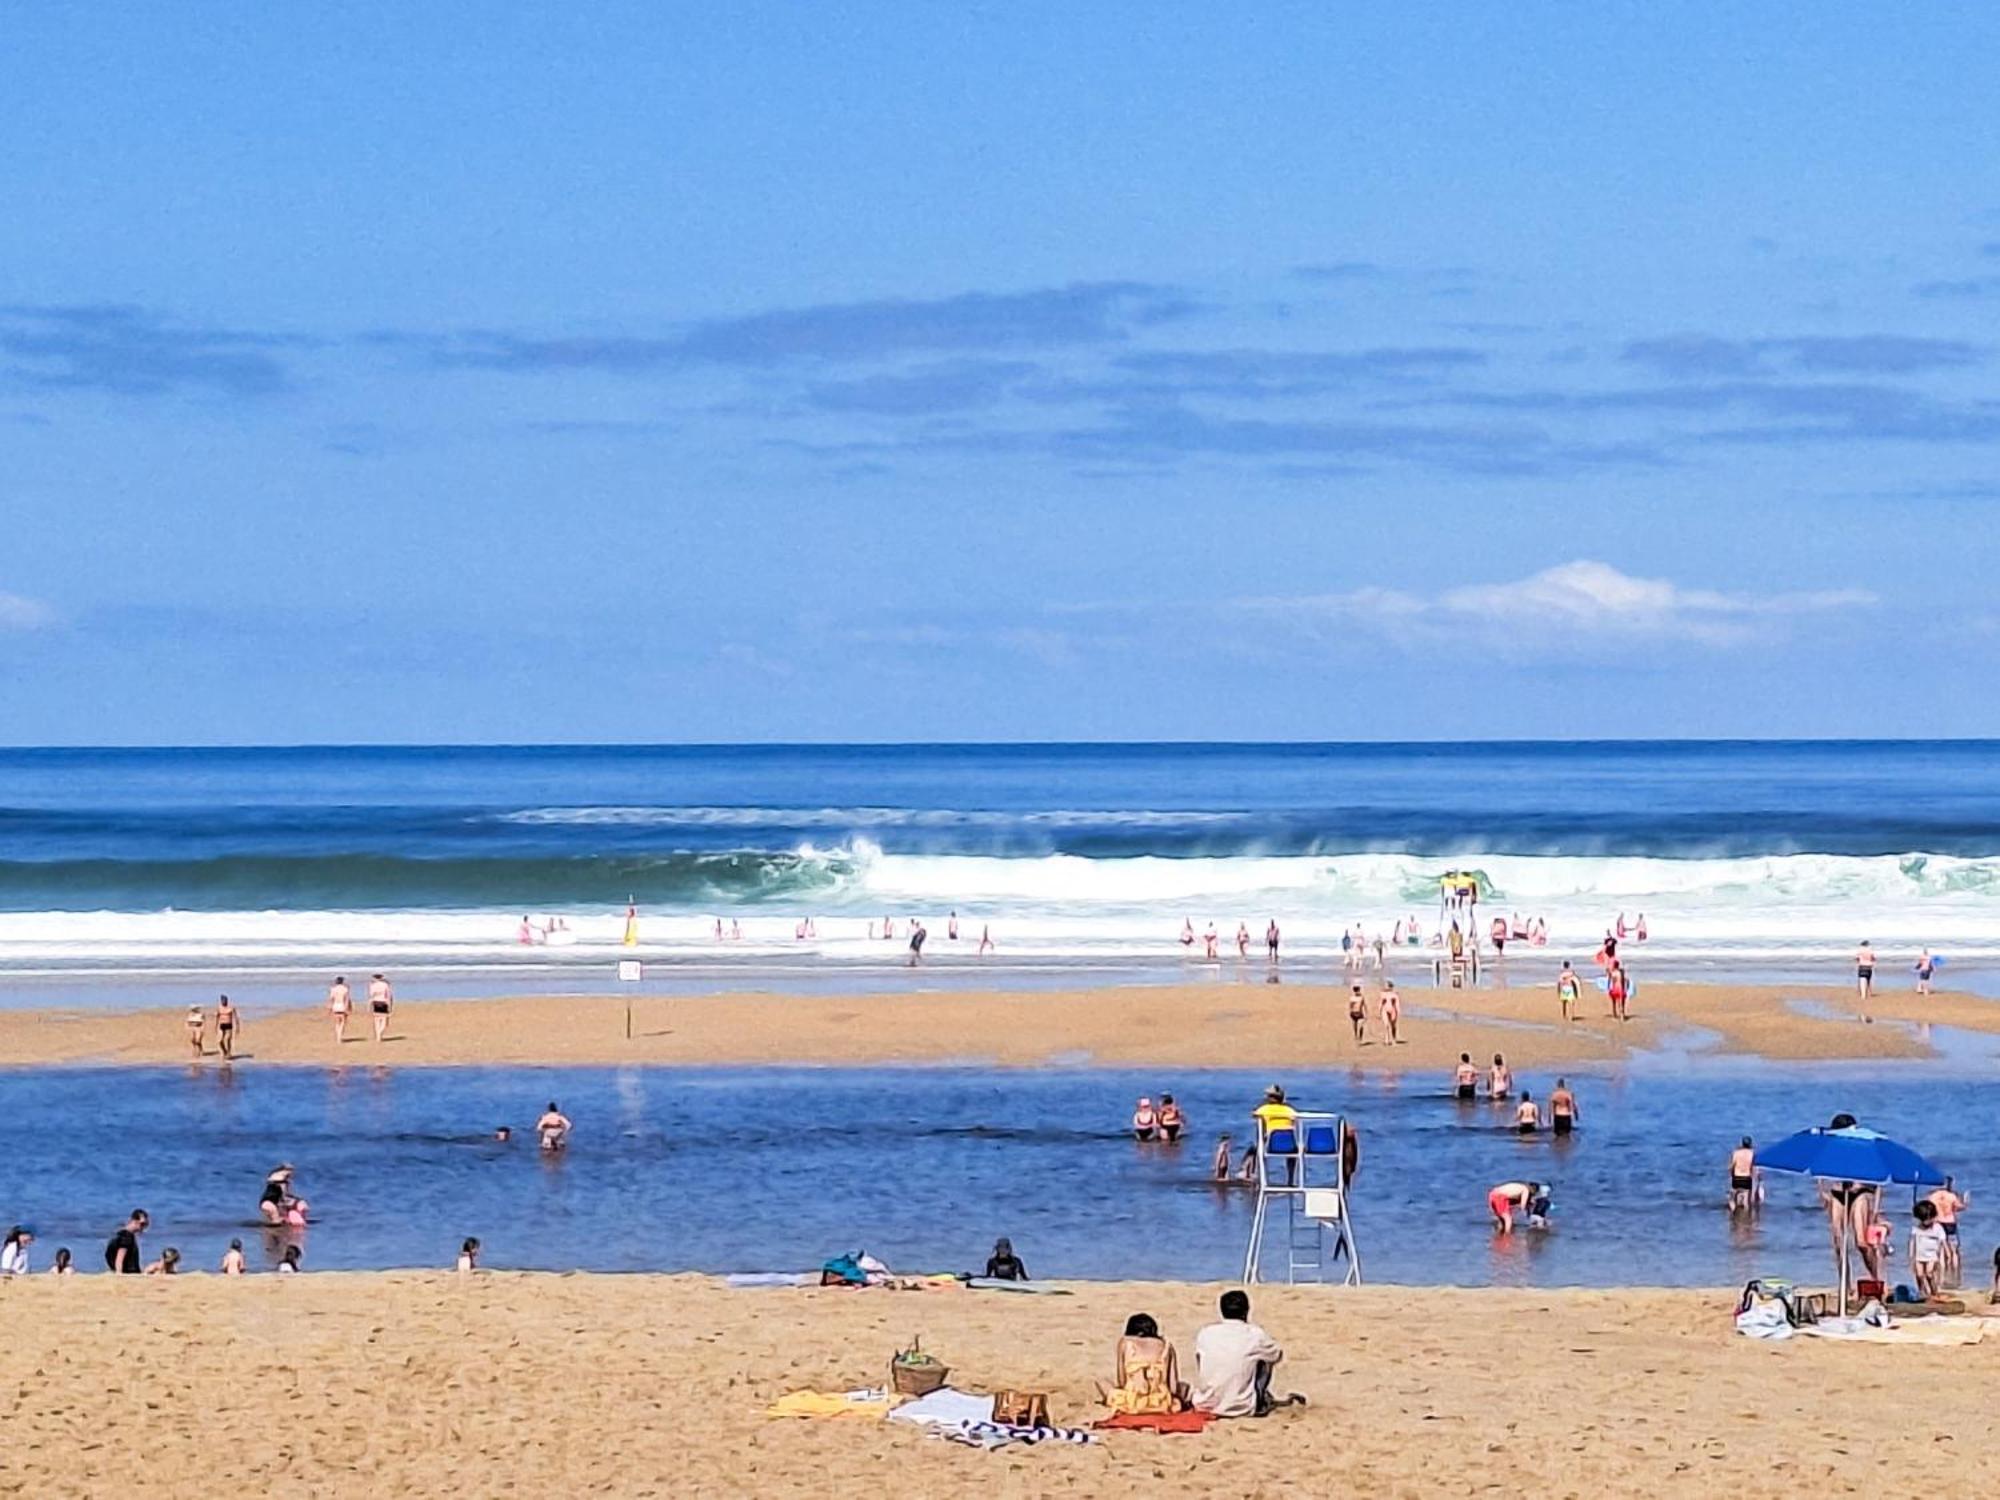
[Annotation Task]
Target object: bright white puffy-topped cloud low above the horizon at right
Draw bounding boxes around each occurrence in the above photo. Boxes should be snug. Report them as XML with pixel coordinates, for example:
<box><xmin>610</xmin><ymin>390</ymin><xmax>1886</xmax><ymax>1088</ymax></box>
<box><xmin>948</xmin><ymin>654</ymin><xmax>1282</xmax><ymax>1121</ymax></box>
<box><xmin>1244</xmin><ymin>560</ymin><xmax>1876</xmax><ymax>646</ymax></box>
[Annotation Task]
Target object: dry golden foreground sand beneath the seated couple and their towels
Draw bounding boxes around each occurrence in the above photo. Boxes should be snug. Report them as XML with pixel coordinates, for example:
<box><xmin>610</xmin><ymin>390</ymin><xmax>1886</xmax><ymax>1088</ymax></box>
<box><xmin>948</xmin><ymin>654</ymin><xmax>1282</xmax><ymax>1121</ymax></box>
<box><xmin>0</xmin><ymin>1272</ymin><xmax>2000</xmax><ymax>1500</ymax></box>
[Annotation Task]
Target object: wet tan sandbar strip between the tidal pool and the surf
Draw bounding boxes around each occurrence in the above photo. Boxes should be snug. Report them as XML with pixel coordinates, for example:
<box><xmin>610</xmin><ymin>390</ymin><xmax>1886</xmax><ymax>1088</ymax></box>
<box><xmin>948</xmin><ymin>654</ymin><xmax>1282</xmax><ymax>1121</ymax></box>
<box><xmin>0</xmin><ymin>978</ymin><xmax>2000</xmax><ymax>1070</ymax></box>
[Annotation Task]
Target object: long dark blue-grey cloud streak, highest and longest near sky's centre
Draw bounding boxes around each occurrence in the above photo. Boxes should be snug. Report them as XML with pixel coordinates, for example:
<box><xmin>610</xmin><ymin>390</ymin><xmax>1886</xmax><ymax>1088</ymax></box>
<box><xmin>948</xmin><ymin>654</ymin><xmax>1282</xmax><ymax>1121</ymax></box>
<box><xmin>406</xmin><ymin>282</ymin><xmax>1192</xmax><ymax>376</ymax></box>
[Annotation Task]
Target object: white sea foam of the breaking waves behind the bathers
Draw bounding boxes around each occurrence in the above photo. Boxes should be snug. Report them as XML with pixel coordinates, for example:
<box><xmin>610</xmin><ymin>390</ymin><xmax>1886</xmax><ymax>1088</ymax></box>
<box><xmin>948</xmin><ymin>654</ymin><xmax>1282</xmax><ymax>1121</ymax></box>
<box><xmin>0</xmin><ymin>842</ymin><xmax>2000</xmax><ymax>972</ymax></box>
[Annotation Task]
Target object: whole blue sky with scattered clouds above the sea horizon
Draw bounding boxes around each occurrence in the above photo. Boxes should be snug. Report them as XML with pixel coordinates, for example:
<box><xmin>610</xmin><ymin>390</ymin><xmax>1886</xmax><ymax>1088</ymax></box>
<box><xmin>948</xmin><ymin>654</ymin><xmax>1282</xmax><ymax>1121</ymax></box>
<box><xmin>0</xmin><ymin>4</ymin><xmax>2000</xmax><ymax>744</ymax></box>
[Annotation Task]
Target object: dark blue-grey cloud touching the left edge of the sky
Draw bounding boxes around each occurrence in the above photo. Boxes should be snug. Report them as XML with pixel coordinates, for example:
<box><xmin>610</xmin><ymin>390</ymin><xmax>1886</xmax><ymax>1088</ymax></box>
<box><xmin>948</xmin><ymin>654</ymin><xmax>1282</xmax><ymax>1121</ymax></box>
<box><xmin>0</xmin><ymin>304</ymin><xmax>316</xmax><ymax>396</ymax></box>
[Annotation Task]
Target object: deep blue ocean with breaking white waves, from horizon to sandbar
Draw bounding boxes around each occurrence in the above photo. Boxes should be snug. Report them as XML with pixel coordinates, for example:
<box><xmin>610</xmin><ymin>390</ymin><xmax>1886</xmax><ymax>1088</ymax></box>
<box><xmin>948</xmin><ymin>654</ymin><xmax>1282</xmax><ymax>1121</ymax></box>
<box><xmin>0</xmin><ymin>742</ymin><xmax>2000</xmax><ymax>1004</ymax></box>
